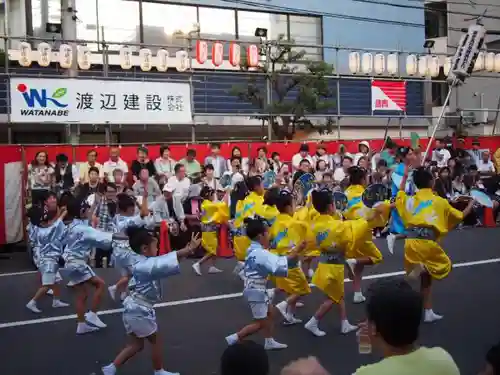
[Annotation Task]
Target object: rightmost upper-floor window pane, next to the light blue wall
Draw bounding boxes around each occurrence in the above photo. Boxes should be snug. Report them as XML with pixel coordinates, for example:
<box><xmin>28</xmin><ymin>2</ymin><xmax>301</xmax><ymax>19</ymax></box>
<box><xmin>290</xmin><ymin>15</ymin><xmax>322</xmax><ymax>61</ymax></box>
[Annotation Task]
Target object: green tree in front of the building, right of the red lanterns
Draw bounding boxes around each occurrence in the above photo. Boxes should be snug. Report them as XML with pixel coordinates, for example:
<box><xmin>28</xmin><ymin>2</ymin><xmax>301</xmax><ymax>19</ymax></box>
<box><xmin>231</xmin><ymin>35</ymin><xmax>335</xmax><ymax>139</ymax></box>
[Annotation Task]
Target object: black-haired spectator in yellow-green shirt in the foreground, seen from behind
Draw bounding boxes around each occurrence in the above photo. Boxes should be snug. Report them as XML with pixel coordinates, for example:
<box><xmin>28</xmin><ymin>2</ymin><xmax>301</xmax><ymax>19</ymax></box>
<box><xmin>355</xmin><ymin>278</ymin><xmax>460</xmax><ymax>375</ymax></box>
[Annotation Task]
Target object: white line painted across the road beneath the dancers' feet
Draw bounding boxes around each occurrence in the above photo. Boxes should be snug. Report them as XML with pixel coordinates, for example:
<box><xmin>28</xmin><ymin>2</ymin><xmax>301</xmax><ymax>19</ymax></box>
<box><xmin>0</xmin><ymin>258</ymin><xmax>500</xmax><ymax>329</ymax></box>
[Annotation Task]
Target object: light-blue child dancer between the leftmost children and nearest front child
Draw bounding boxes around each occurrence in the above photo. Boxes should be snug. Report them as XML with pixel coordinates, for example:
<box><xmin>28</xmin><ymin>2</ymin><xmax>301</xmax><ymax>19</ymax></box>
<box><xmin>61</xmin><ymin>198</ymin><xmax>127</xmax><ymax>334</ymax></box>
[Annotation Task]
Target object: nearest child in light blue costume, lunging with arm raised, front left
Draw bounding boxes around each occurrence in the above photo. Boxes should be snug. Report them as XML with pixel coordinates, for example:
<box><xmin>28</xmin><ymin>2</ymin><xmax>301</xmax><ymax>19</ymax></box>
<box><xmin>102</xmin><ymin>227</ymin><xmax>201</xmax><ymax>375</ymax></box>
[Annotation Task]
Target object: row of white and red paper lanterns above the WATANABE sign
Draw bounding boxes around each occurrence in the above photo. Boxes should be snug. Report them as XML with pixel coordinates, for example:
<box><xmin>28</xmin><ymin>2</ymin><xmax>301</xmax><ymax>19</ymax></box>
<box><xmin>18</xmin><ymin>40</ymin><xmax>260</xmax><ymax>72</ymax></box>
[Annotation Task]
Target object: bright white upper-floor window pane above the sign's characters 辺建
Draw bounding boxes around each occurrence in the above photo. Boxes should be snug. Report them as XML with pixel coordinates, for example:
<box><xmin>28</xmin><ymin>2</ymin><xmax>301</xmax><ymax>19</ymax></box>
<box><xmin>97</xmin><ymin>0</ymin><xmax>140</xmax><ymax>51</ymax></box>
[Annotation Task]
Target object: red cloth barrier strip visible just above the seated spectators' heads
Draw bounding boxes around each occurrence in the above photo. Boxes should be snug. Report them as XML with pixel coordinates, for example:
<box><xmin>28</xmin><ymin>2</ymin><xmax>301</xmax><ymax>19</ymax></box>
<box><xmin>21</xmin><ymin>136</ymin><xmax>500</xmax><ymax>163</ymax></box>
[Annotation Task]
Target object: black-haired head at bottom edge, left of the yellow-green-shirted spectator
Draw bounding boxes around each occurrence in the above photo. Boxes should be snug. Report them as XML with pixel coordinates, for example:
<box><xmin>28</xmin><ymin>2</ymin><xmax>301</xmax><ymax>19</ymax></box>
<box><xmin>220</xmin><ymin>341</ymin><xmax>269</xmax><ymax>375</ymax></box>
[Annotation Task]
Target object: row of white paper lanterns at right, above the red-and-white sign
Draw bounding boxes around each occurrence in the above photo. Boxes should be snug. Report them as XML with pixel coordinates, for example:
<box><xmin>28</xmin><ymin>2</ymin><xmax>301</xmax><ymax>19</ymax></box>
<box><xmin>349</xmin><ymin>52</ymin><xmax>500</xmax><ymax>78</ymax></box>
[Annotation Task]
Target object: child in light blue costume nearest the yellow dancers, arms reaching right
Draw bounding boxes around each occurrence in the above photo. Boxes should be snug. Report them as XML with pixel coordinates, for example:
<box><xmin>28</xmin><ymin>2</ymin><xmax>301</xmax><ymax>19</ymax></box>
<box><xmin>226</xmin><ymin>218</ymin><xmax>305</xmax><ymax>350</ymax></box>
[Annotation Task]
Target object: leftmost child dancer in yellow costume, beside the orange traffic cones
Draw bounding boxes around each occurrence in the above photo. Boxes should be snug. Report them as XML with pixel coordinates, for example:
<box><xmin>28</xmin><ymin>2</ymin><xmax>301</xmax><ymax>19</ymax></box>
<box><xmin>192</xmin><ymin>186</ymin><xmax>229</xmax><ymax>276</ymax></box>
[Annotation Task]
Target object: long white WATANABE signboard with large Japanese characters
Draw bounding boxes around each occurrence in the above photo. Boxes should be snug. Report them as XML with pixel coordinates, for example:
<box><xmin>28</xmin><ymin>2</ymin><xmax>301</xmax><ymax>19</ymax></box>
<box><xmin>10</xmin><ymin>78</ymin><xmax>193</xmax><ymax>124</ymax></box>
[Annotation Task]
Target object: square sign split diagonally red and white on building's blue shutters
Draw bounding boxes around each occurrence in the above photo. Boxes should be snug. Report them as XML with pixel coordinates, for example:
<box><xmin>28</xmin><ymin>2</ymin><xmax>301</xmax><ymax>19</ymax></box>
<box><xmin>372</xmin><ymin>81</ymin><xmax>406</xmax><ymax>112</ymax></box>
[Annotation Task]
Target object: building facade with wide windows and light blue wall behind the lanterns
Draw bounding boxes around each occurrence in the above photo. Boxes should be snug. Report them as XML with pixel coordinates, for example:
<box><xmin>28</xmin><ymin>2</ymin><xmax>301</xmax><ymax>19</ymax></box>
<box><xmin>0</xmin><ymin>0</ymin><xmax>428</xmax><ymax>142</ymax></box>
